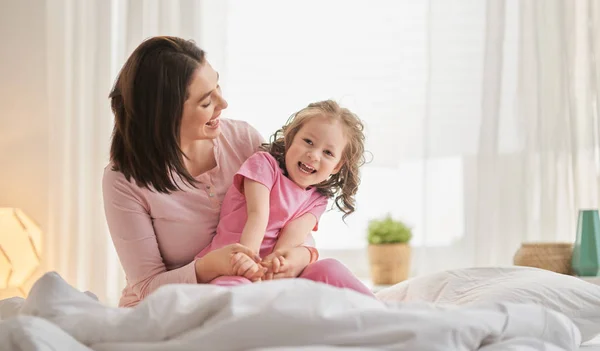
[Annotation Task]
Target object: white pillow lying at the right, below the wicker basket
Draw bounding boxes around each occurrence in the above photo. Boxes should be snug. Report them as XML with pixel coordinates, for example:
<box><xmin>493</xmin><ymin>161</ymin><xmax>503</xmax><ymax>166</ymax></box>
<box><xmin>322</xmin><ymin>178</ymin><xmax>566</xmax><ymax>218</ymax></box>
<box><xmin>376</xmin><ymin>267</ymin><xmax>600</xmax><ymax>341</ymax></box>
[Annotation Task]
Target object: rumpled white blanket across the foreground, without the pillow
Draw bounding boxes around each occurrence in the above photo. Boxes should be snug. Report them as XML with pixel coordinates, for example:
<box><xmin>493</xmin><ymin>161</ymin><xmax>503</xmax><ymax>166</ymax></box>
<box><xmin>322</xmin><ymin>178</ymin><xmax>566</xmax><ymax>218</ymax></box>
<box><xmin>0</xmin><ymin>273</ymin><xmax>581</xmax><ymax>351</ymax></box>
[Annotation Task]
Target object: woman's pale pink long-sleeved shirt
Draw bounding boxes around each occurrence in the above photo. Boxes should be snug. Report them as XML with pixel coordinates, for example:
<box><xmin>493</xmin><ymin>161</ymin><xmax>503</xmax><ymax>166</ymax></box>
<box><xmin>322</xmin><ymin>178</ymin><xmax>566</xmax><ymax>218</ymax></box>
<box><xmin>102</xmin><ymin>119</ymin><xmax>264</xmax><ymax>307</ymax></box>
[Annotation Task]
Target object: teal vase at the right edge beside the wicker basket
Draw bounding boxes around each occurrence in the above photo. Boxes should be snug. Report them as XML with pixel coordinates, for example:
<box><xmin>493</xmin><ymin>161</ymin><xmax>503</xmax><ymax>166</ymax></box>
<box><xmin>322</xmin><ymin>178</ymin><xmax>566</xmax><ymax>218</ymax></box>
<box><xmin>571</xmin><ymin>210</ymin><xmax>600</xmax><ymax>277</ymax></box>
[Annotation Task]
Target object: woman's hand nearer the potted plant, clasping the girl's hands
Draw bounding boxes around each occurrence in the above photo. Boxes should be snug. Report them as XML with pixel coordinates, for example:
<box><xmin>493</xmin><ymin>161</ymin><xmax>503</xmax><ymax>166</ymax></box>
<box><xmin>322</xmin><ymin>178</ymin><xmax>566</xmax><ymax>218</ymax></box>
<box><xmin>261</xmin><ymin>246</ymin><xmax>310</xmax><ymax>280</ymax></box>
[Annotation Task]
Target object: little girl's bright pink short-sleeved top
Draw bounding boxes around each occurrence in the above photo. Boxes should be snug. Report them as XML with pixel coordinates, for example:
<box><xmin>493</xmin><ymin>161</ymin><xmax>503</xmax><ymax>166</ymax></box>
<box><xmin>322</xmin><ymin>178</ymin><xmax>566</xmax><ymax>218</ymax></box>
<box><xmin>198</xmin><ymin>152</ymin><xmax>327</xmax><ymax>257</ymax></box>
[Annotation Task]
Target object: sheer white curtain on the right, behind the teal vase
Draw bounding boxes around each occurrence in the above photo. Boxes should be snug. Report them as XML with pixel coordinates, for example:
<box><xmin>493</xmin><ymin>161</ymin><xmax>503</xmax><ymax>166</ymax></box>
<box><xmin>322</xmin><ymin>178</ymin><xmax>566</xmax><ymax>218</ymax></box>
<box><xmin>470</xmin><ymin>1</ymin><xmax>600</xmax><ymax>265</ymax></box>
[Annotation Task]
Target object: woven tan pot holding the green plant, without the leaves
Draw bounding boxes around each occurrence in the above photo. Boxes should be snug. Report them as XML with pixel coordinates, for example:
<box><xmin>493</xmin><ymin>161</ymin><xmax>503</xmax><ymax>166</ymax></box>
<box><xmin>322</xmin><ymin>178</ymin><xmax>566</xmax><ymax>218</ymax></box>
<box><xmin>369</xmin><ymin>244</ymin><xmax>410</xmax><ymax>285</ymax></box>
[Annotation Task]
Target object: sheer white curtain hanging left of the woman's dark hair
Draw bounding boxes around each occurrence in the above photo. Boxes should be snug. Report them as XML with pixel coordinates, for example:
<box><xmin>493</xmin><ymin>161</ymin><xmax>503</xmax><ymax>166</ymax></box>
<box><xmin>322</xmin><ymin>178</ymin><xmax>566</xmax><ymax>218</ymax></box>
<box><xmin>44</xmin><ymin>1</ymin><xmax>118</xmax><ymax>306</ymax></box>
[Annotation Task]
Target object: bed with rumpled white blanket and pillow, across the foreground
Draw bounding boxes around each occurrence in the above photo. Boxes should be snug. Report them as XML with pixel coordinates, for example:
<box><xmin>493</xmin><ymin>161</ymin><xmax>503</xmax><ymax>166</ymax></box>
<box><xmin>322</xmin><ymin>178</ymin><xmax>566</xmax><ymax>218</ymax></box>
<box><xmin>0</xmin><ymin>268</ymin><xmax>600</xmax><ymax>351</ymax></box>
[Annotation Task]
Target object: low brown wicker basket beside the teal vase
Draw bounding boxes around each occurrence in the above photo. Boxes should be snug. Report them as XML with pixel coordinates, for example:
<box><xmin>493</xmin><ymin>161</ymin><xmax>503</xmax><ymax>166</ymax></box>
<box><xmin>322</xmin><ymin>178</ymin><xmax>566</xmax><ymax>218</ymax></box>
<box><xmin>513</xmin><ymin>243</ymin><xmax>573</xmax><ymax>274</ymax></box>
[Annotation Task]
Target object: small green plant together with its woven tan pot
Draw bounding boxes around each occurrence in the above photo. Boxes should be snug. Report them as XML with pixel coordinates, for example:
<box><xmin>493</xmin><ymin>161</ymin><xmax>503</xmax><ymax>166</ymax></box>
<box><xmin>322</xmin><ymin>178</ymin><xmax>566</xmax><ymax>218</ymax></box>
<box><xmin>368</xmin><ymin>215</ymin><xmax>412</xmax><ymax>285</ymax></box>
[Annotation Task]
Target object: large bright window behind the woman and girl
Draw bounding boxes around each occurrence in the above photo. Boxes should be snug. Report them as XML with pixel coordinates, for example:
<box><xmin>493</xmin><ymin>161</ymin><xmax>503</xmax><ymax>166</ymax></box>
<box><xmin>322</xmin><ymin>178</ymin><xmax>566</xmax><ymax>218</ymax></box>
<box><xmin>220</xmin><ymin>0</ymin><xmax>485</xmax><ymax>258</ymax></box>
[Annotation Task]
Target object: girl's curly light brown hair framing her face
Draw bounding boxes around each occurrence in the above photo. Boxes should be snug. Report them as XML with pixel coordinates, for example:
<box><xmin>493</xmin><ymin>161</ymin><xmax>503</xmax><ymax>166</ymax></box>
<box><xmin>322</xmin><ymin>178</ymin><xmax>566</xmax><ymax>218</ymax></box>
<box><xmin>261</xmin><ymin>100</ymin><xmax>365</xmax><ymax>219</ymax></box>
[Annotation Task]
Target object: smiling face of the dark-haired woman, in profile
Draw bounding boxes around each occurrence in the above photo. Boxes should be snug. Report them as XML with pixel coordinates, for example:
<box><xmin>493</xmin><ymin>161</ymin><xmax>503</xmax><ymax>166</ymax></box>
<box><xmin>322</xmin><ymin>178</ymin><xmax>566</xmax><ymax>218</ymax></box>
<box><xmin>180</xmin><ymin>61</ymin><xmax>227</xmax><ymax>144</ymax></box>
